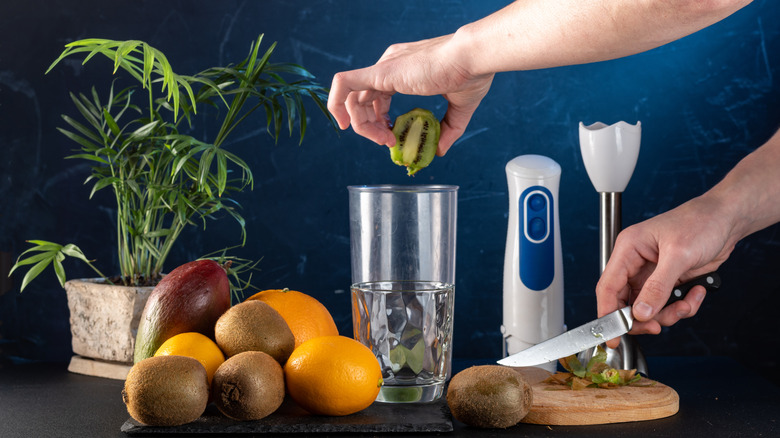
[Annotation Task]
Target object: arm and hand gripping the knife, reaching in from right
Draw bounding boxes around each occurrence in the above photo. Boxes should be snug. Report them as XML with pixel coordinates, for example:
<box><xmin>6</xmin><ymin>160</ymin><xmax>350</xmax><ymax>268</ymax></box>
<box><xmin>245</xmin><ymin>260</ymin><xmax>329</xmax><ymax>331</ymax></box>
<box><xmin>596</xmin><ymin>131</ymin><xmax>780</xmax><ymax>347</ymax></box>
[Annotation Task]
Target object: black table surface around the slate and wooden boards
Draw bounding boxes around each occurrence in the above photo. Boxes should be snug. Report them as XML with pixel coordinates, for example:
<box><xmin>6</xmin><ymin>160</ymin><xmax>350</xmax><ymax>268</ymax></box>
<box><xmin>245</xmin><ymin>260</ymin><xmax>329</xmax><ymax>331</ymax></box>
<box><xmin>0</xmin><ymin>356</ymin><xmax>780</xmax><ymax>438</ymax></box>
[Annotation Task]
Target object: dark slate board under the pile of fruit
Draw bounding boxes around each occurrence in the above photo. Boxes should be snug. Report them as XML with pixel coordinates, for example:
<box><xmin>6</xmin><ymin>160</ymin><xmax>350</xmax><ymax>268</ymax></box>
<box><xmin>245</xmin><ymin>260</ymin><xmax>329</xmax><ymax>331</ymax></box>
<box><xmin>121</xmin><ymin>397</ymin><xmax>452</xmax><ymax>435</ymax></box>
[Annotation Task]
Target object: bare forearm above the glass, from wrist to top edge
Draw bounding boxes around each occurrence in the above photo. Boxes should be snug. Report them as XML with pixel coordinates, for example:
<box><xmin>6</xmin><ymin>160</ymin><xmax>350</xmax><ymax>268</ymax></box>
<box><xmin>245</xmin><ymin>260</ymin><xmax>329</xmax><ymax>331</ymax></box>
<box><xmin>452</xmin><ymin>0</ymin><xmax>751</xmax><ymax>76</ymax></box>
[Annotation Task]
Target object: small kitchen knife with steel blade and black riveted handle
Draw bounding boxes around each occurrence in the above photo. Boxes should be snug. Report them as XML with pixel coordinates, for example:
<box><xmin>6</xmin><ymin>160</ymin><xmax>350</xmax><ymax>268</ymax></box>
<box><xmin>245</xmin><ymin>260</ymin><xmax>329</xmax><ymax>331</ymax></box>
<box><xmin>498</xmin><ymin>272</ymin><xmax>720</xmax><ymax>367</ymax></box>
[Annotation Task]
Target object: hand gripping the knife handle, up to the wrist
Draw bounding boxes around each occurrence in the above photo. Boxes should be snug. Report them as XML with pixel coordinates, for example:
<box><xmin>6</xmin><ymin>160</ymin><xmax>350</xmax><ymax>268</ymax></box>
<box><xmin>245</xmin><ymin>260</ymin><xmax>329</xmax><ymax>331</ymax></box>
<box><xmin>596</xmin><ymin>195</ymin><xmax>737</xmax><ymax>348</ymax></box>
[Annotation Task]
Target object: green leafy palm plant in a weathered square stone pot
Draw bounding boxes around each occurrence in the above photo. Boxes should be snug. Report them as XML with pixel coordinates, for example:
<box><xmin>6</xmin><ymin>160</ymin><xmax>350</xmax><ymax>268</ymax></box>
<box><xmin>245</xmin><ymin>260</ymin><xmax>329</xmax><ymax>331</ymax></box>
<box><xmin>11</xmin><ymin>35</ymin><xmax>334</xmax><ymax>377</ymax></box>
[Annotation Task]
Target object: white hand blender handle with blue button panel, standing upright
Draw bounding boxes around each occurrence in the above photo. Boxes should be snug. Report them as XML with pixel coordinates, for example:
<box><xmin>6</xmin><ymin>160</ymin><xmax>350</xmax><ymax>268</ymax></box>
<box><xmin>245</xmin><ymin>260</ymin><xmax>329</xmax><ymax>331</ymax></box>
<box><xmin>501</xmin><ymin>155</ymin><xmax>566</xmax><ymax>372</ymax></box>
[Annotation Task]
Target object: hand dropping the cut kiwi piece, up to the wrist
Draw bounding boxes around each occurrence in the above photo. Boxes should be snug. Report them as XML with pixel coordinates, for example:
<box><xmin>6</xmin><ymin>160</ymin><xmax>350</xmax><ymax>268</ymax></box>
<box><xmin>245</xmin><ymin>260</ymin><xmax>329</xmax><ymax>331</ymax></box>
<box><xmin>328</xmin><ymin>35</ymin><xmax>493</xmax><ymax>156</ymax></box>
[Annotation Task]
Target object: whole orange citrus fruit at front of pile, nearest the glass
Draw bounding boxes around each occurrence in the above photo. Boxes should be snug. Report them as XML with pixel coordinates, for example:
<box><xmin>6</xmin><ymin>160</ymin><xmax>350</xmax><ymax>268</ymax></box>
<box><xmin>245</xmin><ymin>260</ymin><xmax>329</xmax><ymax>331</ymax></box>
<box><xmin>284</xmin><ymin>336</ymin><xmax>382</xmax><ymax>415</ymax></box>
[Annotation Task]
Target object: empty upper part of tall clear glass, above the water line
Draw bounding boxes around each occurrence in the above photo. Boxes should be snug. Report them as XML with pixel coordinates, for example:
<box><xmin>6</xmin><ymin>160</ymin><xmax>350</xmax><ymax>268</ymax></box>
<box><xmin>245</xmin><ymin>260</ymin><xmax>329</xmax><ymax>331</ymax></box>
<box><xmin>348</xmin><ymin>184</ymin><xmax>458</xmax><ymax>284</ymax></box>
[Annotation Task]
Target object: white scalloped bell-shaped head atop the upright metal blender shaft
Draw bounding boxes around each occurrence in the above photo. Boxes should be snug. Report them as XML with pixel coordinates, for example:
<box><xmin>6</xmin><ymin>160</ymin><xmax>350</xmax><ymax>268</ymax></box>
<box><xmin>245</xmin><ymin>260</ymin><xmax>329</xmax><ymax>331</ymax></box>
<box><xmin>579</xmin><ymin>122</ymin><xmax>642</xmax><ymax>193</ymax></box>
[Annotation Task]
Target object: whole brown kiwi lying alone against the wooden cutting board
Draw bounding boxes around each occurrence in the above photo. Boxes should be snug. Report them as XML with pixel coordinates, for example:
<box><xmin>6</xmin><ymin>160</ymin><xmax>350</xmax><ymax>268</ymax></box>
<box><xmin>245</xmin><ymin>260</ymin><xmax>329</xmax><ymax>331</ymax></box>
<box><xmin>447</xmin><ymin>365</ymin><xmax>533</xmax><ymax>429</ymax></box>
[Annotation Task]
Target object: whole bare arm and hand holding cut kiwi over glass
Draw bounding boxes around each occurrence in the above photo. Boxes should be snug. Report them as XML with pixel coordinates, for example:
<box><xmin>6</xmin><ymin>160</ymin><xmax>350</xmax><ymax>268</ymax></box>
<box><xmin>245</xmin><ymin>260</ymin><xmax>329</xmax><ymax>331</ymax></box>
<box><xmin>328</xmin><ymin>0</ymin><xmax>750</xmax><ymax>155</ymax></box>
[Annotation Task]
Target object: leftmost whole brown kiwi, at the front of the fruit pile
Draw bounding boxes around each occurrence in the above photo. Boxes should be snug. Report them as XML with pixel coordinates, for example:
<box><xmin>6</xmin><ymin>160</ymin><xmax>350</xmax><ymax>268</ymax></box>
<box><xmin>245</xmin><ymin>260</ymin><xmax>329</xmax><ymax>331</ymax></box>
<box><xmin>122</xmin><ymin>356</ymin><xmax>209</xmax><ymax>426</ymax></box>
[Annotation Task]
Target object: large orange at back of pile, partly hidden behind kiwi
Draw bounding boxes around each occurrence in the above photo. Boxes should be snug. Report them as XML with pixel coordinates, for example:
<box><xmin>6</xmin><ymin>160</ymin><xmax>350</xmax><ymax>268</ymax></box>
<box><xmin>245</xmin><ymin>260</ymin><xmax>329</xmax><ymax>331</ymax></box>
<box><xmin>247</xmin><ymin>288</ymin><xmax>339</xmax><ymax>348</ymax></box>
